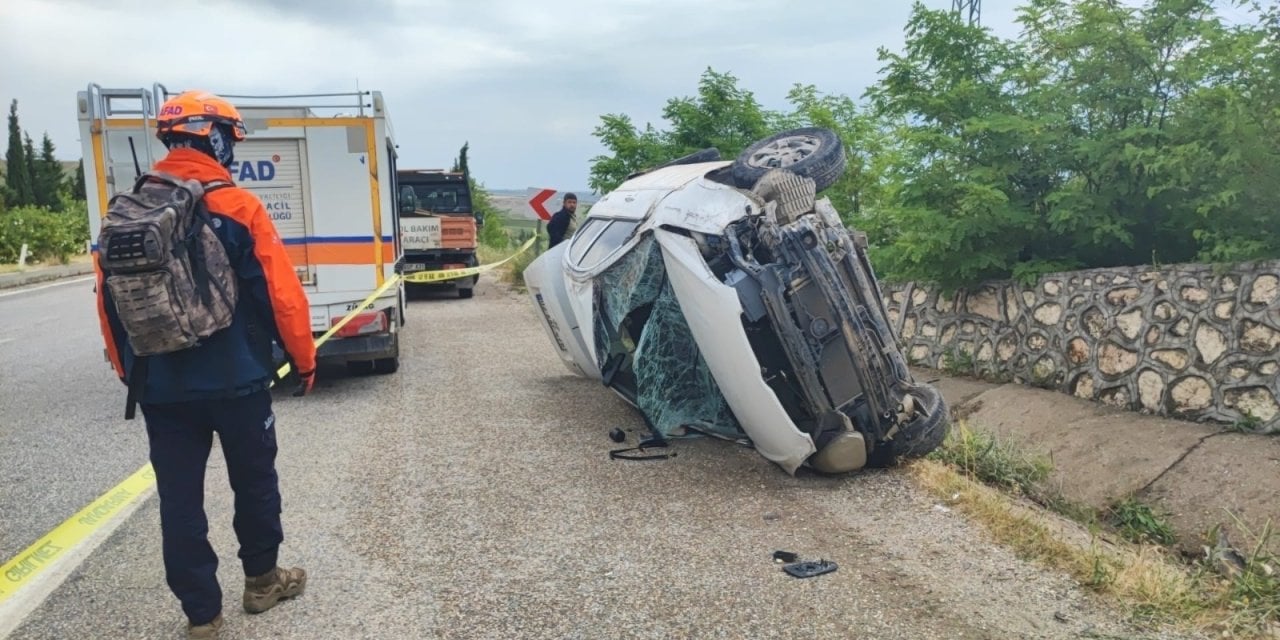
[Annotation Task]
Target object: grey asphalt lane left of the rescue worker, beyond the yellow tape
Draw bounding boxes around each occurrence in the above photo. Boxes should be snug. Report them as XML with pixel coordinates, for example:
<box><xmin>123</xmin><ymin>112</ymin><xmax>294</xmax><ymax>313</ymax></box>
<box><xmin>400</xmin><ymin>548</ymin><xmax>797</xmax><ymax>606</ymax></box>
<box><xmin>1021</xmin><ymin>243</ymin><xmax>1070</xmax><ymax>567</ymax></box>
<box><xmin>0</xmin><ymin>276</ymin><xmax>147</xmax><ymax>561</ymax></box>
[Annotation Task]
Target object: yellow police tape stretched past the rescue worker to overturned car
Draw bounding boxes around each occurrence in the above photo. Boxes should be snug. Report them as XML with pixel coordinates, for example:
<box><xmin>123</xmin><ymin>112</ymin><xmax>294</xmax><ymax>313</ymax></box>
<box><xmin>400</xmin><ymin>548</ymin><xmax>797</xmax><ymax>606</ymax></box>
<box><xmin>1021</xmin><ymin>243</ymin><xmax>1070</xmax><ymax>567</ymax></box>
<box><xmin>0</xmin><ymin>236</ymin><xmax>538</xmax><ymax>605</ymax></box>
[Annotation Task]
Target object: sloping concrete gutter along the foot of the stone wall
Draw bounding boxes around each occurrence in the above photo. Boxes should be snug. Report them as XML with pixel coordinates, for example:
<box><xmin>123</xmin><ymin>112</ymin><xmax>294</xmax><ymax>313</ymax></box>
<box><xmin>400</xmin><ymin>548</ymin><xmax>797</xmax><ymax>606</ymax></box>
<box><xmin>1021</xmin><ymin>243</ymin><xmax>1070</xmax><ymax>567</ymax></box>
<box><xmin>914</xmin><ymin>370</ymin><xmax>1280</xmax><ymax>553</ymax></box>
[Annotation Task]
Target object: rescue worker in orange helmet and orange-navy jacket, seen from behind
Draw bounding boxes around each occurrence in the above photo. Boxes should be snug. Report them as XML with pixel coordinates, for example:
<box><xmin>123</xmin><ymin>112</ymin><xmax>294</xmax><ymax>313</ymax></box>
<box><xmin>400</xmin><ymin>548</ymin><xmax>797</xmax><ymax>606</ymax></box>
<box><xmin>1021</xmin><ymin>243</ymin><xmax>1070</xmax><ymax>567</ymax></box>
<box><xmin>97</xmin><ymin>91</ymin><xmax>316</xmax><ymax>637</ymax></box>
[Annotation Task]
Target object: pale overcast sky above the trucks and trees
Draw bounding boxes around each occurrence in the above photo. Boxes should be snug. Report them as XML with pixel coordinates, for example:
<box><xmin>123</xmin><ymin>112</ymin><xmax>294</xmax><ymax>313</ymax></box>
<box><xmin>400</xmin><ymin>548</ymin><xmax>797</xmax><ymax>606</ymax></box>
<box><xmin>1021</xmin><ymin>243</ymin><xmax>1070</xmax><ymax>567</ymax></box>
<box><xmin>0</xmin><ymin>0</ymin><xmax>1039</xmax><ymax>189</ymax></box>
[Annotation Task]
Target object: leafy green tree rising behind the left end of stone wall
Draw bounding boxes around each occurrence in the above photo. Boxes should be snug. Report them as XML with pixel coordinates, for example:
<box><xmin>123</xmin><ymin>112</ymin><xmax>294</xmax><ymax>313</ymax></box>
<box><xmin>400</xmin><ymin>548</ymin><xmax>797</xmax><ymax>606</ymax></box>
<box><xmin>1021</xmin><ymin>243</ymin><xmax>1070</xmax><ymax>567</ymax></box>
<box><xmin>868</xmin><ymin>4</ymin><xmax>1075</xmax><ymax>287</ymax></box>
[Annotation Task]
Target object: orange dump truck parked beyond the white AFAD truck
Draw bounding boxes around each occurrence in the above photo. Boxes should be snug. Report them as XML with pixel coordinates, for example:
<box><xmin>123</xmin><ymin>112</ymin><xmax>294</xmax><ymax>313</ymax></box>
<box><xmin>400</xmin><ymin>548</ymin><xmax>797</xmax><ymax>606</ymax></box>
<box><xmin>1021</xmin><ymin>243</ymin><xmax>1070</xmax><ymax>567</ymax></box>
<box><xmin>397</xmin><ymin>169</ymin><xmax>483</xmax><ymax>298</ymax></box>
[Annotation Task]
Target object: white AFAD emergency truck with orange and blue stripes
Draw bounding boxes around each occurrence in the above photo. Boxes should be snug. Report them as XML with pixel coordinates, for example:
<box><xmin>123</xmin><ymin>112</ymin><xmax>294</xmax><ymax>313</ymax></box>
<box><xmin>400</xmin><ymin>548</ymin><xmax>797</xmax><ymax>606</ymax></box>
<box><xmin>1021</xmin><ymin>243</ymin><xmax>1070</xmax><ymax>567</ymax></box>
<box><xmin>77</xmin><ymin>84</ymin><xmax>404</xmax><ymax>374</ymax></box>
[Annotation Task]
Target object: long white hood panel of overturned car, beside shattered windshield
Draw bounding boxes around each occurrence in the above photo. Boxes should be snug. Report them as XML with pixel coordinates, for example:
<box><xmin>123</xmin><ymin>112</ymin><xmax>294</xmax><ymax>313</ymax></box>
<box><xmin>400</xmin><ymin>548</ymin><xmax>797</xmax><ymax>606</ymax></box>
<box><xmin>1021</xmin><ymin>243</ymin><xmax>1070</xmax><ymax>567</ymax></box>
<box><xmin>654</xmin><ymin>229</ymin><xmax>817</xmax><ymax>474</ymax></box>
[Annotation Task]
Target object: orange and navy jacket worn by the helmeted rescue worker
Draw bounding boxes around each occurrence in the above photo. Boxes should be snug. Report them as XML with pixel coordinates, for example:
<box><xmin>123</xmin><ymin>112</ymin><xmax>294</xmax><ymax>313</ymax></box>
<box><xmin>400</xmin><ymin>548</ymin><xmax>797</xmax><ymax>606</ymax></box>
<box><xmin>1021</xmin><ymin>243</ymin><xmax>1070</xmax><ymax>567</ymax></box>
<box><xmin>97</xmin><ymin>148</ymin><xmax>316</xmax><ymax>403</ymax></box>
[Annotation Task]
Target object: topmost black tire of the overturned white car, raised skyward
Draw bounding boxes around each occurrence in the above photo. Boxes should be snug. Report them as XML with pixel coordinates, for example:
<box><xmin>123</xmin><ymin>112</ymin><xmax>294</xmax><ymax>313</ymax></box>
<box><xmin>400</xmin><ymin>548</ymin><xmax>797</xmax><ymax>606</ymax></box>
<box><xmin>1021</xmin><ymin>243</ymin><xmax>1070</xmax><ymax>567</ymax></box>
<box><xmin>732</xmin><ymin>127</ymin><xmax>849</xmax><ymax>192</ymax></box>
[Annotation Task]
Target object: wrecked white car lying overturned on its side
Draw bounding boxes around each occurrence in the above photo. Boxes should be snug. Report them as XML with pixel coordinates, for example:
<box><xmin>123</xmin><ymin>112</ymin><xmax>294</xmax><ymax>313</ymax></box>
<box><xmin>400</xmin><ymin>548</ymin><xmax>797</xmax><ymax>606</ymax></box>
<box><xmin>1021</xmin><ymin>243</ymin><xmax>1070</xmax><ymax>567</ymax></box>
<box><xmin>525</xmin><ymin>128</ymin><xmax>948</xmax><ymax>474</ymax></box>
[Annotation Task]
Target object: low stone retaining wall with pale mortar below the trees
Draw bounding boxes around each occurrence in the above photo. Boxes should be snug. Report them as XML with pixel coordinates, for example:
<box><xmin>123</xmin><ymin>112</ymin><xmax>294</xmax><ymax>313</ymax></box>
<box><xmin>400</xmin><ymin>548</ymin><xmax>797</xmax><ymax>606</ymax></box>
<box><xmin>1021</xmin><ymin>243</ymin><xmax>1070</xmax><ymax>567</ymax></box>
<box><xmin>883</xmin><ymin>260</ymin><xmax>1280</xmax><ymax>433</ymax></box>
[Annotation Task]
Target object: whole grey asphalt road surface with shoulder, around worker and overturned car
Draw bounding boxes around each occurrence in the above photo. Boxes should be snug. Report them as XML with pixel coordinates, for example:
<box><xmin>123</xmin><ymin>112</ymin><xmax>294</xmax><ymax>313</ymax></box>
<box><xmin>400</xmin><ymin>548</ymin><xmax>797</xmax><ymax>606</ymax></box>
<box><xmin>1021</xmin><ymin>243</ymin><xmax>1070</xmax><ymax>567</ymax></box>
<box><xmin>0</xmin><ymin>280</ymin><xmax>1203</xmax><ymax>639</ymax></box>
